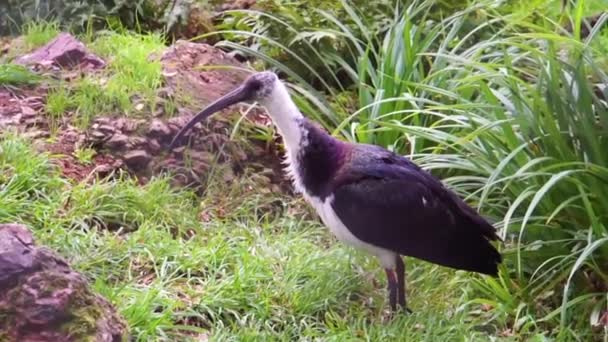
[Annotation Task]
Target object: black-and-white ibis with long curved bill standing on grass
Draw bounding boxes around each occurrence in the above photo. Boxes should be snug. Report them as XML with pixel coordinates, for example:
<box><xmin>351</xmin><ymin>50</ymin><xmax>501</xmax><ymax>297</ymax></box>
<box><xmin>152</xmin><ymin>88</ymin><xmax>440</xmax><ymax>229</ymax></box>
<box><xmin>170</xmin><ymin>71</ymin><xmax>502</xmax><ymax>312</ymax></box>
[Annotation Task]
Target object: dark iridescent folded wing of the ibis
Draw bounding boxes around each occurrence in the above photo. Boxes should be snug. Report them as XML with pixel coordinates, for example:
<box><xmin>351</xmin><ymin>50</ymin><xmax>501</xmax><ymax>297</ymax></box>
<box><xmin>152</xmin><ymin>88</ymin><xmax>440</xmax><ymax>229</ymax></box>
<box><xmin>332</xmin><ymin>145</ymin><xmax>500</xmax><ymax>274</ymax></box>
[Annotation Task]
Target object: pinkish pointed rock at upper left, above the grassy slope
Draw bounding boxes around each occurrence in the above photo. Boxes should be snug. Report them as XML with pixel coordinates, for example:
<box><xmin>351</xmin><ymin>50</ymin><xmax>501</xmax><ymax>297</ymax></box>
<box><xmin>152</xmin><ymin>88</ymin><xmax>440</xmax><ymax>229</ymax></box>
<box><xmin>15</xmin><ymin>32</ymin><xmax>105</xmax><ymax>68</ymax></box>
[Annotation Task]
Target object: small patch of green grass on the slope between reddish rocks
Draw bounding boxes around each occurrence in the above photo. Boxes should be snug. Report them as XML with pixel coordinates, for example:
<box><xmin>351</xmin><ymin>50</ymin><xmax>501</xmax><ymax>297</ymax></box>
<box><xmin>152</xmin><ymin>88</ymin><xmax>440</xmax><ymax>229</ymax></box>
<box><xmin>41</xmin><ymin>31</ymin><xmax>166</xmax><ymax>128</ymax></box>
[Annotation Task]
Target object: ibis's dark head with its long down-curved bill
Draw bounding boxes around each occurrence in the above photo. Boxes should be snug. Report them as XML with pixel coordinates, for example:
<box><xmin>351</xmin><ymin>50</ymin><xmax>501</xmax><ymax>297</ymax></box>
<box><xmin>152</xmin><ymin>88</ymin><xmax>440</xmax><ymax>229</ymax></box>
<box><xmin>171</xmin><ymin>71</ymin><xmax>288</xmax><ymax>148</ymax></box>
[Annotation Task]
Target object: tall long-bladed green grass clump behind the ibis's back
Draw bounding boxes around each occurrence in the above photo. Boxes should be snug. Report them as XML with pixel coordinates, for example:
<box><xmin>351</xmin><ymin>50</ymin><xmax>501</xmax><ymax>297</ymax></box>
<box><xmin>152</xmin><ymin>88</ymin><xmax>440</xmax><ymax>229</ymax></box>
<box><xmin>217</xmin><ymin>1</ymin><xmax>608</xmax><ymax>339</ymax></box>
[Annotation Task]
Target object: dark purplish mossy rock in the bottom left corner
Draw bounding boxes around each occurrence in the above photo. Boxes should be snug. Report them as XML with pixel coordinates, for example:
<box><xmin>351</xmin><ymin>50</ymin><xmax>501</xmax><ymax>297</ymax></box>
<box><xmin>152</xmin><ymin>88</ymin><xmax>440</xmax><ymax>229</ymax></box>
<box><xmin>0</xmin><ymin>224</ymin><xmax>128</xmax><ymax>342</ymax></box>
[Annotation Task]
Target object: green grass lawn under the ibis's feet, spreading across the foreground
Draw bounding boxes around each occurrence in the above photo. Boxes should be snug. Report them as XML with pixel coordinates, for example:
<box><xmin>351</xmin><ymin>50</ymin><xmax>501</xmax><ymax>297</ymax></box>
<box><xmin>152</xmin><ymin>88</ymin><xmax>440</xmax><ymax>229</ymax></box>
<box><xmin>0</xmin><ymin>127</ymin><xmax>560</xmax><ymax>341</ymax></box>
